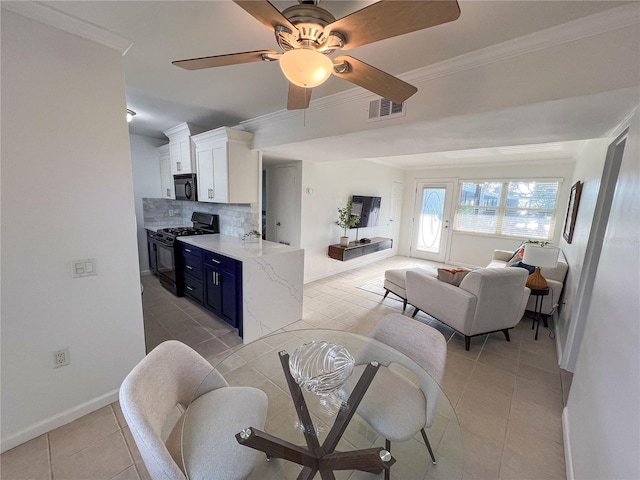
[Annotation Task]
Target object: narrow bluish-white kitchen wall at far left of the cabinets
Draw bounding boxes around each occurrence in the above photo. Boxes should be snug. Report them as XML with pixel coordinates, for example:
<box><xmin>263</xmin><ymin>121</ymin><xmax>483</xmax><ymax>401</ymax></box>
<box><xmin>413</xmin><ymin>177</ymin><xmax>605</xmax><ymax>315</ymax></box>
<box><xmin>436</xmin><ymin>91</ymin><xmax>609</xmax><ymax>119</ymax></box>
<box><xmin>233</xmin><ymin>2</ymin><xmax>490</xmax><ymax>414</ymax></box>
<box><xmin>129</xmin><ymin>134</ymin><xmax>168</xmax><ymax>273</ymax></box>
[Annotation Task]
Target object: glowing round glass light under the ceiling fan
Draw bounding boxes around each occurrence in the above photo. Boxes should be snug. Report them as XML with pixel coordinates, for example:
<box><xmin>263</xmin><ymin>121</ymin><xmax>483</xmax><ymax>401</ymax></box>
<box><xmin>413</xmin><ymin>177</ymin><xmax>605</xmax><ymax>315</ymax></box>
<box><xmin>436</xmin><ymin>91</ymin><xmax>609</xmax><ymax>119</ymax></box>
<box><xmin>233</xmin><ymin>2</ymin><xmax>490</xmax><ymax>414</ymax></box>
<box><xmin>280</xmin><ymin>48</ymin><xmax>333</xmax><ymax>88</ymax></box>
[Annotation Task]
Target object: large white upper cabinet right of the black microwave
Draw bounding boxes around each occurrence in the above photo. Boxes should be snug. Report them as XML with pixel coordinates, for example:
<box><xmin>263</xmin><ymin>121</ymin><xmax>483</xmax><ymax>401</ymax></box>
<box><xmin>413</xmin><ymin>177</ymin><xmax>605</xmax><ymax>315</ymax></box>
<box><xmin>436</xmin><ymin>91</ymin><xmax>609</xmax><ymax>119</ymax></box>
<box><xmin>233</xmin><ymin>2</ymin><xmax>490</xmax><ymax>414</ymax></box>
<box><xmin>191</xmin><ymin>127</ymin><xmax>260</xmax><ymax>203</ymax></box>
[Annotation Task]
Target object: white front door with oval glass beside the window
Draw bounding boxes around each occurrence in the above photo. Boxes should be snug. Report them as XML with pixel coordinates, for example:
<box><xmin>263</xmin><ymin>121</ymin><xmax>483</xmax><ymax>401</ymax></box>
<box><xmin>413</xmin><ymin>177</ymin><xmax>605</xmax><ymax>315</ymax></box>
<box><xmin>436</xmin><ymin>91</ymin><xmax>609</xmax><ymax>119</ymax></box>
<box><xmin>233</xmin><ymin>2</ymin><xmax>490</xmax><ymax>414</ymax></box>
<box><xmin>411</xmin><ymin>182</ymin><xmax>453</xmax><ymax>262</ymax></box>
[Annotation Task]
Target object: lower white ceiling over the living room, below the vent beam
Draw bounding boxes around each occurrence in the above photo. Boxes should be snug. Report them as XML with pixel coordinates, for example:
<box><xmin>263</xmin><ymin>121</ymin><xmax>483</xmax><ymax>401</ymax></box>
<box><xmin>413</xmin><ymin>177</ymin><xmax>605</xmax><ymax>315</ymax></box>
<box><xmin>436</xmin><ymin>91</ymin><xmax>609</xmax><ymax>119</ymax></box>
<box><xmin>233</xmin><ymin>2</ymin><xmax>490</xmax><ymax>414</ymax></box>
<box><xmin>261</xmin><ymin>88</ymin><xmax>640</xmax><ymax>169</ymax></box>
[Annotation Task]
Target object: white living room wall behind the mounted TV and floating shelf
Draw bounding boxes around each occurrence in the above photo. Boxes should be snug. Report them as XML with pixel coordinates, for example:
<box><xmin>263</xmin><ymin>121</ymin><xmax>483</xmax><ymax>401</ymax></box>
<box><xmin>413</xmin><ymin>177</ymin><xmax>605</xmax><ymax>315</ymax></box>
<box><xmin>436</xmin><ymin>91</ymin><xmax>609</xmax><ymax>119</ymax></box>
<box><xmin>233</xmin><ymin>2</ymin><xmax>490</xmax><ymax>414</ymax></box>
<box><xmin>301</xmin><ymin>160</ymin><xmax>403</xmax><ymax>283</ymax></box>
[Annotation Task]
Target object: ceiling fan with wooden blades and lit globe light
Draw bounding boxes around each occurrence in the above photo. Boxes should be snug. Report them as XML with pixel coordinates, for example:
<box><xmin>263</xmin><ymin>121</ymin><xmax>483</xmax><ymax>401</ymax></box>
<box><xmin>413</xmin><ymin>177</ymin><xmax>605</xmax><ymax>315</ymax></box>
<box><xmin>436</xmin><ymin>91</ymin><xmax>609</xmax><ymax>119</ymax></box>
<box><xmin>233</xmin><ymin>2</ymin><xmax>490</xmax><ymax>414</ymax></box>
<box><xmin>172</xmin><ymin>0</ymin><xmax>460</xmax><ymax>110</ymax></box>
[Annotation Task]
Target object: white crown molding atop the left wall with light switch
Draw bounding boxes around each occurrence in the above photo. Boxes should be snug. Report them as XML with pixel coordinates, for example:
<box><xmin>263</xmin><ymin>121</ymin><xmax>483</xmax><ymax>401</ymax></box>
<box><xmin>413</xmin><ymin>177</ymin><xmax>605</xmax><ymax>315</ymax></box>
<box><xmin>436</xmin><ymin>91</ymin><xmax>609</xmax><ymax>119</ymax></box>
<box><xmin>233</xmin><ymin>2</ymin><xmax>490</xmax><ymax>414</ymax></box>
<box><xmin>2</xmin><ymin>1</ymin><xmax>133</xmax><ymax>55</ymax></box>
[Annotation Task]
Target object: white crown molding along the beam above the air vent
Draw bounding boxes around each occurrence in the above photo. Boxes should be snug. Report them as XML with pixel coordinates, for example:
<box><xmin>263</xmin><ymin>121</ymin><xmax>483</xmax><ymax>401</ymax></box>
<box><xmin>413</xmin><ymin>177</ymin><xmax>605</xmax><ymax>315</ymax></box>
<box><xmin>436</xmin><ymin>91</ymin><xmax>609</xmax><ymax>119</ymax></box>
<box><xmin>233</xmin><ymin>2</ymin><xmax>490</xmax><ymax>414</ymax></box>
<box><xmin>240</xmin><ymin>3</ymin><xmax>640</xmax><ymax>130</ymax></box>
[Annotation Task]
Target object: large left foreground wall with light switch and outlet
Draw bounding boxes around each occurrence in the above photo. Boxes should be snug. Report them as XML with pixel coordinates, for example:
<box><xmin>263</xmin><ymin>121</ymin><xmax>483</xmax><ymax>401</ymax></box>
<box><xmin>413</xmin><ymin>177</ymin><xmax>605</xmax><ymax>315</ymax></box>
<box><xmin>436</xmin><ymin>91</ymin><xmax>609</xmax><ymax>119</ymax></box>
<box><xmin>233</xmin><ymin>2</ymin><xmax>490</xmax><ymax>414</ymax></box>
<box><xmin>1</xmin><ymin>10</ymin><xmax>145</xmax><ymax>451</ymax></box>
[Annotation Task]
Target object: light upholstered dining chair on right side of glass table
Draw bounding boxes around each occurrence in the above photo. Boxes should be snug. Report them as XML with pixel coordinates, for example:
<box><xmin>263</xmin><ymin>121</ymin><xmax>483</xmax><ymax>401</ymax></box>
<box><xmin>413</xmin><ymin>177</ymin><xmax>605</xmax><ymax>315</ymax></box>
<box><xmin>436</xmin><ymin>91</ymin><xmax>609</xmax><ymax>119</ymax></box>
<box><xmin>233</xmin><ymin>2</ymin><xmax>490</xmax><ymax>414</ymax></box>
<box><xmin>345</xmin><ymin>313</ymin><xmax>447</xmax><ymax>470</ymax></box>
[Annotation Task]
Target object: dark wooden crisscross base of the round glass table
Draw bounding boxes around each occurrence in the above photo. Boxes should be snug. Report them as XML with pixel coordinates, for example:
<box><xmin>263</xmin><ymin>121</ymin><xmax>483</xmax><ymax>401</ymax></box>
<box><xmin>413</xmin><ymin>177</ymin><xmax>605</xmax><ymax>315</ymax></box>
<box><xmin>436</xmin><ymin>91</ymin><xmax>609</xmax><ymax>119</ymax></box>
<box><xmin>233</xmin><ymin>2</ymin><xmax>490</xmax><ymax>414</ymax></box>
<box><xmin>236</xmin><ymin>350</ymin><xmax>396</xmax><ymax>480</ymax></box>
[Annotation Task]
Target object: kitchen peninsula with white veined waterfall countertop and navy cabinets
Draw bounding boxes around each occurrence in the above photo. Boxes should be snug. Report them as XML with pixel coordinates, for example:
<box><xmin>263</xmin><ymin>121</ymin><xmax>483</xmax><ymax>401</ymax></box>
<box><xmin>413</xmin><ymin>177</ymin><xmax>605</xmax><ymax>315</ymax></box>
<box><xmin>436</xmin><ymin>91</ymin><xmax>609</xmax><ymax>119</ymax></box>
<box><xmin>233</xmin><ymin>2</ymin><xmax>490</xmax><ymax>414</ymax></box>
<box><xmin>179</xmin><ymin>234</ymin><xmax>304</xmax><ymax>344</ymax></box>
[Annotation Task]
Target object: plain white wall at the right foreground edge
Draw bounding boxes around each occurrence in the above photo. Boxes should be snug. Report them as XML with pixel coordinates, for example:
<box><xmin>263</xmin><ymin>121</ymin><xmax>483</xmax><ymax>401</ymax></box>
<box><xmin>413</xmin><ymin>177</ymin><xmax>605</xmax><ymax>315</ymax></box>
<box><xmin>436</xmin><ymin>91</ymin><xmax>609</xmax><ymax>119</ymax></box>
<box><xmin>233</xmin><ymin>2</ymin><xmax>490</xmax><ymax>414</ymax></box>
<box><xmin>563</xmin><ymin>109</ymin><xmax>640</xmax><ymax>479</ymax></box>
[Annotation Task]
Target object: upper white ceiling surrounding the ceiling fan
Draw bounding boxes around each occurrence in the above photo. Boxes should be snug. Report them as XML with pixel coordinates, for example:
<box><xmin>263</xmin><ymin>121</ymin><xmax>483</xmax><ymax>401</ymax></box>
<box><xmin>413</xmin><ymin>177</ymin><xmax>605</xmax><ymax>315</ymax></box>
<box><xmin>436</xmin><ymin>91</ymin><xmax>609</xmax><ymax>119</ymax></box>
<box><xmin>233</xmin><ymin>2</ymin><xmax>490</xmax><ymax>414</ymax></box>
<box><xmin>43</xmin><ymin>0</ymin><xmax>628</xmax><ymax>129</ymax></box>
